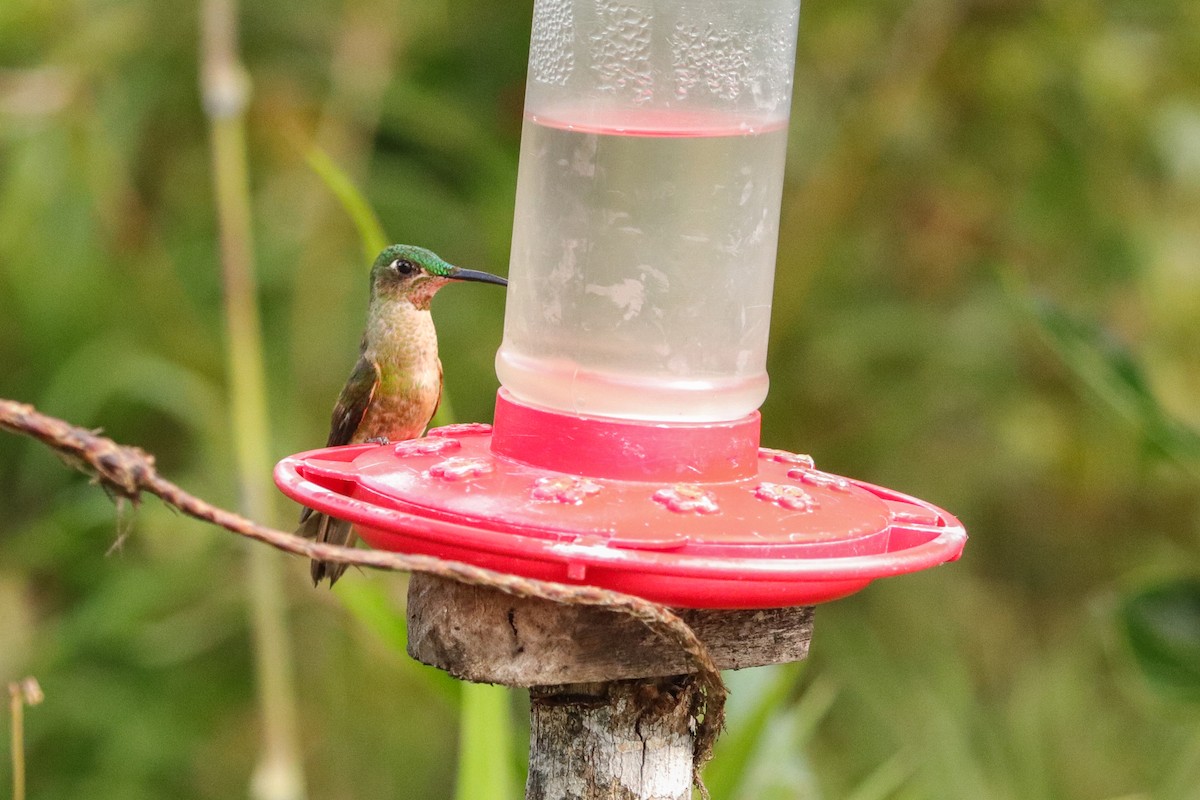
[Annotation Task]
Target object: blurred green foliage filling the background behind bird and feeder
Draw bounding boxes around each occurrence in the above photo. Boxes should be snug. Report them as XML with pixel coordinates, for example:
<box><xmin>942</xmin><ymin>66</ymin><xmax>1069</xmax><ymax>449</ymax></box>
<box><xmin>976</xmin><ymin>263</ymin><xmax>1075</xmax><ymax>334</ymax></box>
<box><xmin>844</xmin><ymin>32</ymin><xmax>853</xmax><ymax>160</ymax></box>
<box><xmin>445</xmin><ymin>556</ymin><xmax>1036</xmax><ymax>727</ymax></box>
<box><xmin>0</xmin><ymin>0</ymin><xmax>1200</xmax><ymax>800</ymax></box>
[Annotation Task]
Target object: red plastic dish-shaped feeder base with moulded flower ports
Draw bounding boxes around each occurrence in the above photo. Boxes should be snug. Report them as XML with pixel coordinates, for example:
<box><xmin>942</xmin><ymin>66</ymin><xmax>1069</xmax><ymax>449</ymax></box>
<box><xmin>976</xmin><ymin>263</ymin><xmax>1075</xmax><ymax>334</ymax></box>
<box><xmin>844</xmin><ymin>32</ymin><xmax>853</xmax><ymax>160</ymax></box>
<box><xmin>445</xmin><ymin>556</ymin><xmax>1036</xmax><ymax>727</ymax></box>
<box><xmin>275</xmin><ymin>392</ymin><xmax>966</xmax><ymax>608</ymax></box>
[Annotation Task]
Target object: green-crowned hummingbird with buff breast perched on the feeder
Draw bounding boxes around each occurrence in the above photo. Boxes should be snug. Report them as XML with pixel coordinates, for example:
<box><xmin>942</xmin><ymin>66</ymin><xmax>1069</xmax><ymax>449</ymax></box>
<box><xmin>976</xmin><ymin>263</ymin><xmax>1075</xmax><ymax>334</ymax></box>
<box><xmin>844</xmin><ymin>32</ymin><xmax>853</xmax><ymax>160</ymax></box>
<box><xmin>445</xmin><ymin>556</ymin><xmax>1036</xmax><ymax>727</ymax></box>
<box><xmin>296</xmin><ymin>245</ymin><xmax>508</xmax><ymax>587</ymax></box>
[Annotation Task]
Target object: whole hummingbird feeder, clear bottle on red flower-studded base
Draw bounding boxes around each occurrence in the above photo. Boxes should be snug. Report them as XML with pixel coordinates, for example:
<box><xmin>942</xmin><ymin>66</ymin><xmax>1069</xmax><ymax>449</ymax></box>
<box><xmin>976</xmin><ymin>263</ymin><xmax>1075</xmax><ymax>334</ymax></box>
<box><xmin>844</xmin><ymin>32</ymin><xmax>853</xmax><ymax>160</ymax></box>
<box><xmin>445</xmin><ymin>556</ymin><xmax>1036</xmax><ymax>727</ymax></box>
<box><xmin>275</xmin><ymin>0</ymin><xmax>966</xmax><ymax>796</ymax></box>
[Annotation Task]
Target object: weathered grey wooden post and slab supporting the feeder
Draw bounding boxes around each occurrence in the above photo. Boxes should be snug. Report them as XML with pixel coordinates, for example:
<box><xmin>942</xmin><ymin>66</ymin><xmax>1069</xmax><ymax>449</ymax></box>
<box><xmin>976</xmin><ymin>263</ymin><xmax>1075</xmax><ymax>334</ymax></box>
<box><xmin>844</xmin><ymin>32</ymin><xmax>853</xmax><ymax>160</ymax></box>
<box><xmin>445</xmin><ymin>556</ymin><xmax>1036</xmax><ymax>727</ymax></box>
<box><xmin>408</xmin><ymin>573</ymin><xmax>812</xmax><ymax>800</ymax></box>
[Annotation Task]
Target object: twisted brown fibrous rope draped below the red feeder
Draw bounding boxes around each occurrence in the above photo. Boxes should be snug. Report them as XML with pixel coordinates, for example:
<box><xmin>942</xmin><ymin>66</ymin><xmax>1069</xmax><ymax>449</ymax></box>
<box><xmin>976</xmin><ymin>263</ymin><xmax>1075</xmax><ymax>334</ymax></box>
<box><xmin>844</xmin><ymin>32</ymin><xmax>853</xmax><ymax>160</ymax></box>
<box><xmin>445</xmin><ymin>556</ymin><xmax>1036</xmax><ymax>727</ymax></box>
<box><xmin>0</xmin><ymin>399</ymin><xmax>726</xmax><ymax>798</ymax></box>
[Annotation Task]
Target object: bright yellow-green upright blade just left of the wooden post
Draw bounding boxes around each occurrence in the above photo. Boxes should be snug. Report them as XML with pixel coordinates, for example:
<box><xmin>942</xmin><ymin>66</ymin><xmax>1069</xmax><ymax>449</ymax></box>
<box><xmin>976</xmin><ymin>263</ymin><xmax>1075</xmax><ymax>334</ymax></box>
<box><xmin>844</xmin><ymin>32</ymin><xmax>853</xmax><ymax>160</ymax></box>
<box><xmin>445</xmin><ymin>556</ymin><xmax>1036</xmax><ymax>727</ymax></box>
<box><xmin>455</xmin><ymin>682</ymin><xmax>517</xmax><ymax>800</ymax></box>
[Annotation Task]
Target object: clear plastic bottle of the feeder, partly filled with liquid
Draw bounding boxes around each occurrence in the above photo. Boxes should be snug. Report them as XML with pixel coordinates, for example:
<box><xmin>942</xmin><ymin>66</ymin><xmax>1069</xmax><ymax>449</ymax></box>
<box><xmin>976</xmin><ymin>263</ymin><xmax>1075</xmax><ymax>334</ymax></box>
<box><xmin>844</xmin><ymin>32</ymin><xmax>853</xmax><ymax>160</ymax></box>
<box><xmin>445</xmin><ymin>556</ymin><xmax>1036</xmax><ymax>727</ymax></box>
<box><xmin>497</xmin><ymin>0</ymin><xmax>799</xmax><ymax>422</ymax></box>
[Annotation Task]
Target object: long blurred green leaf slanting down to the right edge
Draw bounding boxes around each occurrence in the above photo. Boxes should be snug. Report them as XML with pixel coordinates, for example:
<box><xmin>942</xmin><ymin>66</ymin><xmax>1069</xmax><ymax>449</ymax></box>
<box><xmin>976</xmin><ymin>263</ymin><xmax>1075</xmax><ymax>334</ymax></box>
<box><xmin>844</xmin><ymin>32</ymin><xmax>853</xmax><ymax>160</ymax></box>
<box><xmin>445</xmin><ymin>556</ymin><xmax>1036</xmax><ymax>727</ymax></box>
<box><xmin>1007</xmin><ymin>281</ymin><xmax>1200</xmax><ymax>479</ymax></box>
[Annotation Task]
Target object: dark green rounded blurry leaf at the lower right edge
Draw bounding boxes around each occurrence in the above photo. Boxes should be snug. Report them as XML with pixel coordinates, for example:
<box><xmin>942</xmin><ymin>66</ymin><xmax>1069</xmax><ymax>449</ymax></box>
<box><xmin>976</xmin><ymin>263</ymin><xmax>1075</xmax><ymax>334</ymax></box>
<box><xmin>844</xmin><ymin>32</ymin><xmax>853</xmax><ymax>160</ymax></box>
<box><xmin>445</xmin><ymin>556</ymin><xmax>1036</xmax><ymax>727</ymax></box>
<box><xmin>1118</xmin><ymin>577</ymin><xmax>1200</xmax><ymax>702</ymax></box>
